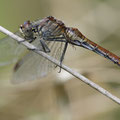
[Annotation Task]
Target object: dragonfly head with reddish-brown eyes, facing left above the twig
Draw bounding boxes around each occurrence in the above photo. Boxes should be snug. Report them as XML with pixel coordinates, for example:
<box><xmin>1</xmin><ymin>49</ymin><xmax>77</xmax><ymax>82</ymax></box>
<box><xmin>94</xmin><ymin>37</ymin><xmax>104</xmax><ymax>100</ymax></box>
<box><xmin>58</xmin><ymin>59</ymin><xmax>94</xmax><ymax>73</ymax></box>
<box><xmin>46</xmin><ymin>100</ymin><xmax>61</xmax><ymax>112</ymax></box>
<box><xmin>19</xmin><ymin>21</ymin><xmax>34</xmax><ymax>40</ymax></box>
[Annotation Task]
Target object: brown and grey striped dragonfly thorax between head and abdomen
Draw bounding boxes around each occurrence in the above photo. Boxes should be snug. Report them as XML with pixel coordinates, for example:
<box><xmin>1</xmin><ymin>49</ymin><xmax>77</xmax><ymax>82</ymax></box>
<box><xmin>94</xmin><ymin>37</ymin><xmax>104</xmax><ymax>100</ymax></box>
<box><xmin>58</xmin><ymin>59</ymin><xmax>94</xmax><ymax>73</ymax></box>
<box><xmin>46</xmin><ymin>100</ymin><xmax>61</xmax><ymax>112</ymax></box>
<box><xmin>38</xmin><ymin>16</ymin><xmax>65</xmax><ymax>38</ymax></box>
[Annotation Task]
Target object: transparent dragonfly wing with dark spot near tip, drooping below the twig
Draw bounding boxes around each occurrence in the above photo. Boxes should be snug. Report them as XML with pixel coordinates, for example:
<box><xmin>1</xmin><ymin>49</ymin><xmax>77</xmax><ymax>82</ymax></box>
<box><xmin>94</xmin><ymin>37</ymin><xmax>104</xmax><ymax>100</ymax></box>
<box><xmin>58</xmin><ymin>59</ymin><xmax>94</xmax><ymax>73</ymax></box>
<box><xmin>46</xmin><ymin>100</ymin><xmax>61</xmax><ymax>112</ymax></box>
<box><xmin>12</xmin><ymin>36</ymin><xmax>64</xmax><ymax>83</ymax></box>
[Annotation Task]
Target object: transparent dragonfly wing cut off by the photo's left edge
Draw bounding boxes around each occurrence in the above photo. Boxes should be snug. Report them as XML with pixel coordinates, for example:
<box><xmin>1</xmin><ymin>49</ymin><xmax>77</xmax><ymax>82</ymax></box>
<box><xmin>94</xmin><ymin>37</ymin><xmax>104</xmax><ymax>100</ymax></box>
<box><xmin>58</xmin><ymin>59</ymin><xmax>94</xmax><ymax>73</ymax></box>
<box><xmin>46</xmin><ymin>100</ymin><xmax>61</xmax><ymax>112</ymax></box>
<box><xmin>0</xmin><ymin>32</ymin><xmax>26</xmax><ymax>66</ymax></box>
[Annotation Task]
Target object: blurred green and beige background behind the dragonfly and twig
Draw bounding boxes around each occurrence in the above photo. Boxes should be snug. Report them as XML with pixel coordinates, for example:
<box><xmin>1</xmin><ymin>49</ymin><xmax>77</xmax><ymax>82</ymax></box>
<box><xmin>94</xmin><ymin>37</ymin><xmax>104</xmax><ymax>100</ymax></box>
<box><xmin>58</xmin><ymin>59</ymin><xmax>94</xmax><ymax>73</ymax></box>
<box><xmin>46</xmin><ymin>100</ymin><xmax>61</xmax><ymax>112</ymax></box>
<box><xmin>0</xmin><ymin>0</ymin><xmax>120</xmax><ymax>120</ymax></box>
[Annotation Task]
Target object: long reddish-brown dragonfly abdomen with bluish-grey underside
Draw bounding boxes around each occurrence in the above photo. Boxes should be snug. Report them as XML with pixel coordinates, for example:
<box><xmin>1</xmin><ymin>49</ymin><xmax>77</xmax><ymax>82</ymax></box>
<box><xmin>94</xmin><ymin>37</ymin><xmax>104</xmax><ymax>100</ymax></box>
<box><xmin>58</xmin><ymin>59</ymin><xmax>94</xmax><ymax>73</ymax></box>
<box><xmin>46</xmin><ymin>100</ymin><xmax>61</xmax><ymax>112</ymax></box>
<box><xmin>66</xmin><ymin>27</ymin><xmax>120</xmax><ymax>65</ymax></box>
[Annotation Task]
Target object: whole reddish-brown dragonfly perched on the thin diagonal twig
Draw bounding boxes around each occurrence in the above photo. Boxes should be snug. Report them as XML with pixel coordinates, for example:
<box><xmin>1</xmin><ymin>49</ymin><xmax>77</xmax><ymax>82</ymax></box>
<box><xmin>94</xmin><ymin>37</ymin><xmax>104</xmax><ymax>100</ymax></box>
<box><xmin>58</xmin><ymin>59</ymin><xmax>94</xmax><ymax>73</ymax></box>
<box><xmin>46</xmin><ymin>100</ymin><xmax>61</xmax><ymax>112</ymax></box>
<box><xmin>0</xmin><ymin>16</ymin><xmax>120</xmax><ymax>83</ymax></box>
